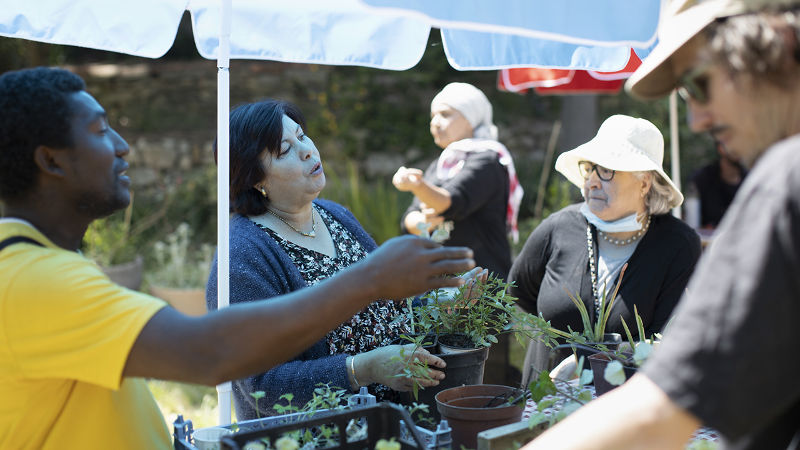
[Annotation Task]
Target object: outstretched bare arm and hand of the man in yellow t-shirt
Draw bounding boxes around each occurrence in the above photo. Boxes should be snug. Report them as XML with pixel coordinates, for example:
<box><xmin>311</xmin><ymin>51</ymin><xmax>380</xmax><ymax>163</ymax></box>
<box><xmin>123</xmin><ymin>236</ymin><xmax>475</xmax><ymax>385</ymax></box>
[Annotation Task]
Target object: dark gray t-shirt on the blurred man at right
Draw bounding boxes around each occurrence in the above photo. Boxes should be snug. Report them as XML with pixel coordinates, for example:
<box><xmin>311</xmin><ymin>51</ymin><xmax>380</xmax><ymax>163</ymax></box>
<box><xmin>644</xmin><ymin>137</ymin><xmax>800</xmax><ymax>449</ymax></box>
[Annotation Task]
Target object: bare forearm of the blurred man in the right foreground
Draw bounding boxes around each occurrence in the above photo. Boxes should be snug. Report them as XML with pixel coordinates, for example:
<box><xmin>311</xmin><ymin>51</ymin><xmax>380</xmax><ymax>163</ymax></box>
<box><xmin>523</xmin><ymin>375</ymin><xmax>700</xmax><ymax>450</ymax></box>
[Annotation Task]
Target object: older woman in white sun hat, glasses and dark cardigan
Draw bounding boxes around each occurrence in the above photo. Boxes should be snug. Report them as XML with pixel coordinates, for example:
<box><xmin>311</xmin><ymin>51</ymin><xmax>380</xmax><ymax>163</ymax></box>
<box><xmin>509</xmin><ymin>115</ymin><xmax>700</xmax><ymax>380</ymax></box>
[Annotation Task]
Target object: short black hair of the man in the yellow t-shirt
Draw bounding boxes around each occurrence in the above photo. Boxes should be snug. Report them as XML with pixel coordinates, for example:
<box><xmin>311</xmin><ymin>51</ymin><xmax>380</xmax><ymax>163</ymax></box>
<box><xmin>0</xmin><ymin>67</ymin><xmax>86</xmax><ymax>200</ymax></box>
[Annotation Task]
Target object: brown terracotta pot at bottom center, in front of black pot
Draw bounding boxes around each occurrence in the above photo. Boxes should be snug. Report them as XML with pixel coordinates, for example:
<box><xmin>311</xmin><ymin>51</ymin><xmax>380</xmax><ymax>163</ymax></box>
<box><xmin>436</xmin><ymin>384</ymin><xmax>523</xmax><ymax>449</ymax></box>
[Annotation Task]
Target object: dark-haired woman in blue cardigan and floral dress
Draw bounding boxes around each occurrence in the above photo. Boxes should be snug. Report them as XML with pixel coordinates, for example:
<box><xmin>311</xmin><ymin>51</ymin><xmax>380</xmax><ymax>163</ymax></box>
<box><xmin>206</xmin><ymin>100</ymin><xmax>472</xmax><ymax>420</ymax></box>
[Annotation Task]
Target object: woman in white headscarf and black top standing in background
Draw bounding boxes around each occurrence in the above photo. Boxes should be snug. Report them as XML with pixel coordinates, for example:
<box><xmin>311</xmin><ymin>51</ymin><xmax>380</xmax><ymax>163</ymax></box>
<box><xmin>392</xmin><ymin>83</ymin><xmax>522</xmax><ymax>279</ymax></box>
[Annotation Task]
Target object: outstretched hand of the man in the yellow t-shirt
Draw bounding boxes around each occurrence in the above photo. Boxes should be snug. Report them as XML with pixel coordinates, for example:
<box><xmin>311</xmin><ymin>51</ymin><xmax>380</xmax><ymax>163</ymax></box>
<box><xmin>359</xmin><ymin>235</ymin><xmax>475</xmax><ymax>299</ymax></box>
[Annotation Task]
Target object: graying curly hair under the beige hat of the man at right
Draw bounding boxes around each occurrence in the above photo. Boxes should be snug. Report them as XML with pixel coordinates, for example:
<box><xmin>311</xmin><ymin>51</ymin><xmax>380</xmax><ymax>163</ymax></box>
<box><xmin>706</xmin><ymin>6</ymin><xmax>800</xmax><ymax>88</ymax></box>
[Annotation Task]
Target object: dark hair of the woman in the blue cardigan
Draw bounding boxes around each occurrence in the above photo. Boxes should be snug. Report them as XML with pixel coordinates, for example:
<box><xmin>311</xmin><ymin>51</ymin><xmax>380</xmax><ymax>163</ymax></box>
<box><xmin>214</xmin><ymin>99</ymin><xmax>306</xmax><ymax>216</ymax></box>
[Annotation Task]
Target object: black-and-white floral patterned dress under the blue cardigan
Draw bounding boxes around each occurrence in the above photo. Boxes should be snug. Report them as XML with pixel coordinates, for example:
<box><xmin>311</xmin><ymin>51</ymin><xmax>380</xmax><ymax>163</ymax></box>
<box><xmin>256</xmin><ymin>207</ymin><xmax>409</xmax><ymax>401</ymax></box>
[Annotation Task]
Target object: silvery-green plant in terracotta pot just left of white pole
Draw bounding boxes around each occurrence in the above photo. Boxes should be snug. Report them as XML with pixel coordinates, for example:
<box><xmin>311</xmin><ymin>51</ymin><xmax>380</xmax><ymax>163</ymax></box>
<box><xmin>146</xmin><ymin>223</ymin><xmax>213</xmax><ymax>315</ymax></box>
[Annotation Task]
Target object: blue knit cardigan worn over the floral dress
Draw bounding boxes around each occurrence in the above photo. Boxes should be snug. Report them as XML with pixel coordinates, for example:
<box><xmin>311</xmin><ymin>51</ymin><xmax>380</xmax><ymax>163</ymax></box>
<box><xmin>206</xmin><ymin>199</ymin><xmax>377</xmax><ymax>421</ymax></box>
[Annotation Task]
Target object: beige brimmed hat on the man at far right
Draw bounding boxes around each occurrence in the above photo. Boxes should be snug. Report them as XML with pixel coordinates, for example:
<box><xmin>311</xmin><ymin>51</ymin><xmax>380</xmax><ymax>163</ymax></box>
<box><xmin>625</xmin><ymin>0</ymin><xmax>800</xmax><ymax>99</ymax></box>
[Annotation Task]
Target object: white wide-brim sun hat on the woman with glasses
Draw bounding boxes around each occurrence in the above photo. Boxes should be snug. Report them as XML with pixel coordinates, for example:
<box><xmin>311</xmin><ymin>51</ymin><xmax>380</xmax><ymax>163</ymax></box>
<box><xmin>556</xmin><ymin>114</ymin><xmax>683</xmax><ymax>208</ymax></box>
